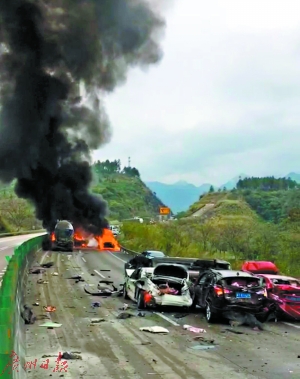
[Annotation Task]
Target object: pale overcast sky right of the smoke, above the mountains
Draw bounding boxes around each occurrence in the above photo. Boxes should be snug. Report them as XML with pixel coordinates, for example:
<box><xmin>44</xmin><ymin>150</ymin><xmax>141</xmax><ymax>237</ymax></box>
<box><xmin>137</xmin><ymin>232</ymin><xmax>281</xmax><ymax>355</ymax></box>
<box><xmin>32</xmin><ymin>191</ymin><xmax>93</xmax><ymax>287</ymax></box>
<box><xmin>94</xmin><ymin>0</ymin><xmax>300</xmax><ymax>185</ymax></box>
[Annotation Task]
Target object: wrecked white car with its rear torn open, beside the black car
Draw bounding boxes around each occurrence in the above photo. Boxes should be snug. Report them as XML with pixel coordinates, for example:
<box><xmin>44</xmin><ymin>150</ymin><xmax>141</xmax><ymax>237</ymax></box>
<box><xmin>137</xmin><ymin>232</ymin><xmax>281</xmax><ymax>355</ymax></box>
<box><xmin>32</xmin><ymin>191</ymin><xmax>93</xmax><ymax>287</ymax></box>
<box><xmin>124</xmin><ymin>263</ymin><xmax>193</xmax><ymax>309</ymax></box>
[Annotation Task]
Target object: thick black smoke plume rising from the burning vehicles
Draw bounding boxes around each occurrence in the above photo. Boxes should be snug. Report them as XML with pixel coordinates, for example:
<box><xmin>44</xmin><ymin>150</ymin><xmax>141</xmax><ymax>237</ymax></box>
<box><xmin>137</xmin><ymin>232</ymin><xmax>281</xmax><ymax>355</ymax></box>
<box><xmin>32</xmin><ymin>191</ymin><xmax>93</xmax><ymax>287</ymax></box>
<box><xmin>0</xmin><ymin>0</ymin><xmax>164</xmax><ymax>233</ymax></box>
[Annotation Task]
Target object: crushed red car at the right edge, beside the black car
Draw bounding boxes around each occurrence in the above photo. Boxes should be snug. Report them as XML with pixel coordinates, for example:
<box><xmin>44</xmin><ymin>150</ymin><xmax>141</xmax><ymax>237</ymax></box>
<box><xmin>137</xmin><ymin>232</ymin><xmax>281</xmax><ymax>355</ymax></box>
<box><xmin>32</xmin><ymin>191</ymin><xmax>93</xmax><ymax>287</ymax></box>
<box><xmin>243</xmin><ymin>262</ymin><xmax>300</xmax><ymax>320</ymax></box>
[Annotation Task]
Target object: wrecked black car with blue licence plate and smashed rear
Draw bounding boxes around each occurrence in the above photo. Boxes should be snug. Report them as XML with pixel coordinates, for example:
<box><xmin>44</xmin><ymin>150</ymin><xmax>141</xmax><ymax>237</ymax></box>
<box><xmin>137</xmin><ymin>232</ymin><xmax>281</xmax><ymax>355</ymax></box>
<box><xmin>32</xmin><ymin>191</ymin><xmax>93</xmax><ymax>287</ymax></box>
<box><xmin>191</xmin><ymin>269</ymin><xmax>269</xmax><ymax>322</ymax></box>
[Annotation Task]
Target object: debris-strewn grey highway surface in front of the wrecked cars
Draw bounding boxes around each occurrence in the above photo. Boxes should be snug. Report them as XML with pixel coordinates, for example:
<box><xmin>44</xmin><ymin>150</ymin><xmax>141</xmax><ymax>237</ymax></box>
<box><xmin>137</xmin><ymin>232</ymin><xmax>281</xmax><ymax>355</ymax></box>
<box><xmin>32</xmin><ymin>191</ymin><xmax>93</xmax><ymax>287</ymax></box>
<box><xmin>22</xmin><ymin>250</ymin><xmax>300</xmax><ymax>379</ymax></box>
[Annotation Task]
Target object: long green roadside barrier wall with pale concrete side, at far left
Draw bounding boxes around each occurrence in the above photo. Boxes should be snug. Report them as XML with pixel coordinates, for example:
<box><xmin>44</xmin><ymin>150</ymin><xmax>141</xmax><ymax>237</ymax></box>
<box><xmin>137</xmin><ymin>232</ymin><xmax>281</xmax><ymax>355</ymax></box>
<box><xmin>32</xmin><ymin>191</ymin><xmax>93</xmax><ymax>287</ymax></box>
<box><xmin>0</xmin><ymin>236</ymin><xmax>43</xmax><ymax>379</ymax></box>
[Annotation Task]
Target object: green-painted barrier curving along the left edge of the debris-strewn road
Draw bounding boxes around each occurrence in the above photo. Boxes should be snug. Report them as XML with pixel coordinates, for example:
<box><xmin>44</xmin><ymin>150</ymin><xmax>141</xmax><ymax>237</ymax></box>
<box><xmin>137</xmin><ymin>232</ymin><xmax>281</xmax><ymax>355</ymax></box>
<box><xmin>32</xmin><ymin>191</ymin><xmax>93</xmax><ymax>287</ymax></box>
<box><xmin>0</xmin><ymin>236</ymin><xmax>44</xmax><ymax>379</ymax></box>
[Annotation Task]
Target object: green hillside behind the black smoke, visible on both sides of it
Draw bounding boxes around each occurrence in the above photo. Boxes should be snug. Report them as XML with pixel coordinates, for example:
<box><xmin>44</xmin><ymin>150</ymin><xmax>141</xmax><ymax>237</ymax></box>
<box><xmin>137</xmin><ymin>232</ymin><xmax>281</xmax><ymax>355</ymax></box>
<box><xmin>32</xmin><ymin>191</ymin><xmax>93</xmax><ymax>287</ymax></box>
<box><xmin>0</xmin><ymin>160</ymin><xmax>164</xmax><ymax>233</ymax></box>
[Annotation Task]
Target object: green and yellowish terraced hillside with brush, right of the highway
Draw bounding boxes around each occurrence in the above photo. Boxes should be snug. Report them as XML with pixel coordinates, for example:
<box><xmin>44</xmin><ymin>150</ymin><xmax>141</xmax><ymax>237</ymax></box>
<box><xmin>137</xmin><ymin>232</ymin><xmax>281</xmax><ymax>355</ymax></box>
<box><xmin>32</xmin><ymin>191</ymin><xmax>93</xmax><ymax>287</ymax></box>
<box><xmin>121</xmin><ymin>178</ymin><xmax>300</xmax><ymax>276</ymax></box>
